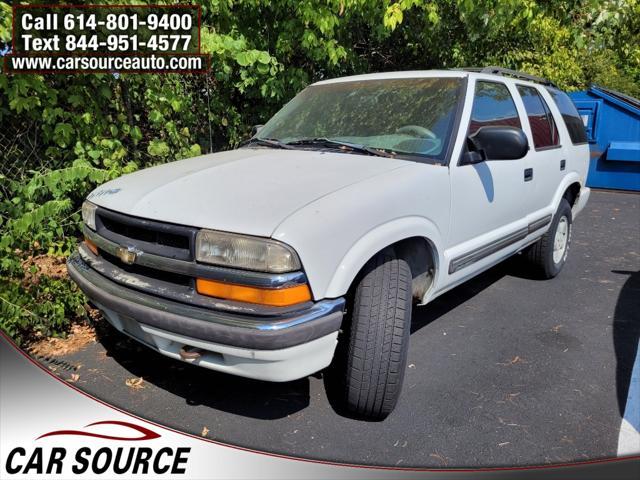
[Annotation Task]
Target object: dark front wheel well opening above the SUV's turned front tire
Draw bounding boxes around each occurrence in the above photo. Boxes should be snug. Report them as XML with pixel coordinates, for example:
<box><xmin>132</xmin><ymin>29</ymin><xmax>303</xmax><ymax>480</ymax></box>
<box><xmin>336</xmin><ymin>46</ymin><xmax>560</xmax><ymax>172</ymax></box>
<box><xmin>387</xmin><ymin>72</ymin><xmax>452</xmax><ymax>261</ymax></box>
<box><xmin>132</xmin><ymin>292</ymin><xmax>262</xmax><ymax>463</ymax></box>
<box><xmin>349</xmin><ymin>236</ymin><xmax>438</xmax><ymax>302</ymax></box>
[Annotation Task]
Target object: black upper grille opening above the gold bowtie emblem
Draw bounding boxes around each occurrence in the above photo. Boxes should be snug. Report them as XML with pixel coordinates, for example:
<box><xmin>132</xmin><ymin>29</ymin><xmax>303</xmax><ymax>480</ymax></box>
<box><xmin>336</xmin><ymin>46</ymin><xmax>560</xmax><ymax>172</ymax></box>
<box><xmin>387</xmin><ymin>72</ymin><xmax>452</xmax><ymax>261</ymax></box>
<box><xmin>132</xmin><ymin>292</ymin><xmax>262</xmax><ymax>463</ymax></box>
<box><xmin>96</xmin><ymin>208</ymin><xmax>196</xmax><ymax>260</ymax></box>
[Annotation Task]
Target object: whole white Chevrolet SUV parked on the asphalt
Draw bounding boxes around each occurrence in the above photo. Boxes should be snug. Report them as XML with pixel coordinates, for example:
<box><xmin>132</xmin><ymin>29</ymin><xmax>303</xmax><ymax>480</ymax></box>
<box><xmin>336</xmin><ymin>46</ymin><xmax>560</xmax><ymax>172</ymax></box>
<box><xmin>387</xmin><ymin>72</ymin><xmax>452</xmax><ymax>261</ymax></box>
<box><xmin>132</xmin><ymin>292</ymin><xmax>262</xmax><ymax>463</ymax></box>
<box><xmin>68</xmin><ymin>68</ymin><xmax>589</xmax><ymax>418</ymax></box>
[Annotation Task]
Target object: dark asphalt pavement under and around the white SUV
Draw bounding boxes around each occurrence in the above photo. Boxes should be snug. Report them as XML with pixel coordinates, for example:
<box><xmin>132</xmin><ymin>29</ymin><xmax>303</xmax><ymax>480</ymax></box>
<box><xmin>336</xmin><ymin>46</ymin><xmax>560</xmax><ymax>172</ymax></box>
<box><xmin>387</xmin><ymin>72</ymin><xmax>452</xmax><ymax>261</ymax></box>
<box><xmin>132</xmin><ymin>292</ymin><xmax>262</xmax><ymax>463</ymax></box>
<box><xmin>36</xmin><ymin>191</ymin><xmax>640</xmax><ymax>467</ymax></box>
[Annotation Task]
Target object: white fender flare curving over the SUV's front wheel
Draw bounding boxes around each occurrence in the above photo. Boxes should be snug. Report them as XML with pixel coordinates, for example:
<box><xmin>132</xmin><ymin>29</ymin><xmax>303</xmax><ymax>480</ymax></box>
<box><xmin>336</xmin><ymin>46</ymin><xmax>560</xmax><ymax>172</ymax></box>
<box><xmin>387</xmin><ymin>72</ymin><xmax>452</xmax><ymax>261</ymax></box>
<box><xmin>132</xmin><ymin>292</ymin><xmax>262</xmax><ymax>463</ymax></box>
<box><xmin>324</xmin><ymin>216</ymin><xmax>443</xmax><ymax>298</ymax></box>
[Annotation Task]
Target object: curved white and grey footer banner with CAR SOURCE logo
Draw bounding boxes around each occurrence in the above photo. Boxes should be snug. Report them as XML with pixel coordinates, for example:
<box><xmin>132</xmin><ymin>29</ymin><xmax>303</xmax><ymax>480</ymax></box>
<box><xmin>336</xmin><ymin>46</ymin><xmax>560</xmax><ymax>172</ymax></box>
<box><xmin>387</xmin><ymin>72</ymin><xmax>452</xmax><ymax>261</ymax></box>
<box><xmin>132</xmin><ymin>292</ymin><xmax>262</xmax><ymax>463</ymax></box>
<box><xmin>0</xmin><ymin>334</ymin><xmax>640</xmax><ymax>480</ymax></box>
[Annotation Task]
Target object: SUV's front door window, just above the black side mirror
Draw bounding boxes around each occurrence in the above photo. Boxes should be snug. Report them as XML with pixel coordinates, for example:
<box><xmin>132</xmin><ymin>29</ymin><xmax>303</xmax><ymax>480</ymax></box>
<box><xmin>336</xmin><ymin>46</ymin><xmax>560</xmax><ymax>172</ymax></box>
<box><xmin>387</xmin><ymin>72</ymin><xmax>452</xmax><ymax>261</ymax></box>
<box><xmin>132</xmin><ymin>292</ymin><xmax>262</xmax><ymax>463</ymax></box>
<box><xmin>469</xmin><ymin>81</ymin><xmax>522</xmax><ymax>135</ymax></box>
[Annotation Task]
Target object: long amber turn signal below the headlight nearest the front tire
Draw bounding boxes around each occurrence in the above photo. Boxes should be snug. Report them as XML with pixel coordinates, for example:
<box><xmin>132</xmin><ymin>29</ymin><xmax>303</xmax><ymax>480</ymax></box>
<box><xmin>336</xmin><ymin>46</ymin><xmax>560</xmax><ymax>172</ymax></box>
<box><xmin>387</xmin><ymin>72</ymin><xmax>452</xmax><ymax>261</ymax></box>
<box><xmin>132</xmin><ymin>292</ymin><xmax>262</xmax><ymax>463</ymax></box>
<box><xmin>196</xmin><ymin>278</ymin><xmax>311</xmax><ymax>307</ymax></box>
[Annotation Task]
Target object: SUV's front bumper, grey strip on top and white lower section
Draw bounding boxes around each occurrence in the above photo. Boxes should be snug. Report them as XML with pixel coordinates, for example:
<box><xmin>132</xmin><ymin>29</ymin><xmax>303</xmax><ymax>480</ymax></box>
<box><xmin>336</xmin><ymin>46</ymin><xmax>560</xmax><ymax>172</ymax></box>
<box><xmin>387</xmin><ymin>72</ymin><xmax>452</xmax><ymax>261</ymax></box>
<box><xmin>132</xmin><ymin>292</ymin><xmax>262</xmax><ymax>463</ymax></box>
<box><xmin>67</xmin><ymin>253</ymin><xmax>345</xmax><ymax>381</ymax></box>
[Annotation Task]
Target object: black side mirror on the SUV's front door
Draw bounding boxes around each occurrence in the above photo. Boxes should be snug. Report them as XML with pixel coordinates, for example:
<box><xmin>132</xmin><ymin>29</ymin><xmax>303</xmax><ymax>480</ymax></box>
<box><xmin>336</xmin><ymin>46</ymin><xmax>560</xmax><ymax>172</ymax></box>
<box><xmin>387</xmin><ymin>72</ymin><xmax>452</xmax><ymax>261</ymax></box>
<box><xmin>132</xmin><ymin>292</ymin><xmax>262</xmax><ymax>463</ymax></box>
<box><xmin>463</xmin><ymin>126</ymin><xmax>529</xmax><ymax>164</ymax></box>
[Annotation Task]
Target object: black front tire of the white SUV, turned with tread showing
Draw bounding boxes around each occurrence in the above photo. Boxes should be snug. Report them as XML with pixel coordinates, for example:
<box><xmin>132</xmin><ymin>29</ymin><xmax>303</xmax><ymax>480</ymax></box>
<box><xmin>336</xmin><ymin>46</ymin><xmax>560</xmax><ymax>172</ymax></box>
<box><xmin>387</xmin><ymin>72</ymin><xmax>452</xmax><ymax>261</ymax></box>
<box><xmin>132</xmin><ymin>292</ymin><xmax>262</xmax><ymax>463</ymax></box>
<box><xmin>338</xmin><ymin>252</ymin><xmax>412</xmax><ymax>420</ymax></box>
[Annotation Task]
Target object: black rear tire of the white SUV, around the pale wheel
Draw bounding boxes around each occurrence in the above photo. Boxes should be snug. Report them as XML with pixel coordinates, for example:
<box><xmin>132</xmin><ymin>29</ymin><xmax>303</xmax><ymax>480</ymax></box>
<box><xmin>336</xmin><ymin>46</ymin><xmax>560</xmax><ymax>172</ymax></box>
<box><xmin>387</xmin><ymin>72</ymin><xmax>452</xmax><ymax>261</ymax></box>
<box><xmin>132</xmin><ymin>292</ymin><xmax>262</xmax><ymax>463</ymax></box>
<box><xmin>525</xmin><ymin>198</ymin><xmax>573</xmax><ymax>278</ymax></box>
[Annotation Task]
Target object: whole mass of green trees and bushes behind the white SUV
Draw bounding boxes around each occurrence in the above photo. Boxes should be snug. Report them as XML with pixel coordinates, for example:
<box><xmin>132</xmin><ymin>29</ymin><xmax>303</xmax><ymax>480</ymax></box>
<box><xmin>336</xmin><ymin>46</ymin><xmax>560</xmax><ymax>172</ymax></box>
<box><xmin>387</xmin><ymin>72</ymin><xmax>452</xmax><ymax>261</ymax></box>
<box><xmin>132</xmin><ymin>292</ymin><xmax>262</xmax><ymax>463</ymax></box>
<box><xmin>0</xmin><ymin>0</ymin><xmax>640</xmax><ymax>340</ymax></box>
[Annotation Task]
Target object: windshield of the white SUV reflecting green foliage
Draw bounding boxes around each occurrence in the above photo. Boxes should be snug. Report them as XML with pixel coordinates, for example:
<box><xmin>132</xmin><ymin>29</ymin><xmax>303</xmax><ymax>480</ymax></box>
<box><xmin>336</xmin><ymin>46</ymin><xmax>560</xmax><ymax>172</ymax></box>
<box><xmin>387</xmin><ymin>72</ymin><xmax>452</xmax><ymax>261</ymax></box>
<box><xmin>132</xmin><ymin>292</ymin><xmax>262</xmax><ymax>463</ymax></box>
<box><xmin>255</xmin><ymin>78</ymin><xmax>462</xmax><ymax>161</ymax></box>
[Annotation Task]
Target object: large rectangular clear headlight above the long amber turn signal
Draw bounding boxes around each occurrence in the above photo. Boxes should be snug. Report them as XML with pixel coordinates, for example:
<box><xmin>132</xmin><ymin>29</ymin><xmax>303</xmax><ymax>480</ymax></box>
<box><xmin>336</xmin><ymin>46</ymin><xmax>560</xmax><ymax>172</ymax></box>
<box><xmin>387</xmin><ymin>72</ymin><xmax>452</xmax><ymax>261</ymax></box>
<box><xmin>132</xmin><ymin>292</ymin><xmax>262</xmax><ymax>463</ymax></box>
<box><xmin>196</xmin><ymin>230</ymin><xmax>301</xmax><ymax>273</ymax></box>
